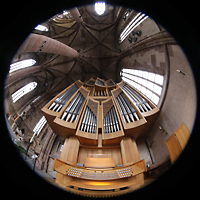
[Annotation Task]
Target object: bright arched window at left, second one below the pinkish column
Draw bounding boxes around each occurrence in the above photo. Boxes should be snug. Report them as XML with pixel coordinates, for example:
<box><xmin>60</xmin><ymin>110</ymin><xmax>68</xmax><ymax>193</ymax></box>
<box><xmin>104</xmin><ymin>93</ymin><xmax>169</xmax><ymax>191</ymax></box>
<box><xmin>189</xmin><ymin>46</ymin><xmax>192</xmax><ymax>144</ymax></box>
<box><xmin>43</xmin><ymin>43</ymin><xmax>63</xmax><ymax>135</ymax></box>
<box><xmin>11</xmin><ymin>82</ymin><xmax>37</xmax><ymax>103</ymax></box>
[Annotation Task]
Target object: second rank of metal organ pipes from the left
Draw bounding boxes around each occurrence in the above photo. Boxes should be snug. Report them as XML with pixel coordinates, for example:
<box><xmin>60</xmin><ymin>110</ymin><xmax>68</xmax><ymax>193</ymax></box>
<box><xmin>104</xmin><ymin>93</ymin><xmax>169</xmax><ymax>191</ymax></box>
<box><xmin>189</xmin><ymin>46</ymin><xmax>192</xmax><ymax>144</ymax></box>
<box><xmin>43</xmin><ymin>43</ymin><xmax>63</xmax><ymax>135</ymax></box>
<box><xmin>61</xmin><ymin>92</ymin><xmax>85</xmax><ymax>123</ymax></box>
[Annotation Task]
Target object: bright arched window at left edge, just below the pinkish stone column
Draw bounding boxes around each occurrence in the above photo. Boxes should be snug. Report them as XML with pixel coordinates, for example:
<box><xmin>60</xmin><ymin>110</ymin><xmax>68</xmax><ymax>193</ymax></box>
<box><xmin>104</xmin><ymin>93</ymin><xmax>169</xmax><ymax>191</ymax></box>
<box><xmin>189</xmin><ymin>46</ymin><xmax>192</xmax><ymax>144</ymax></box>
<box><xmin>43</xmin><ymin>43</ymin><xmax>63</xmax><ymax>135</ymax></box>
<box><xmin>9</xmin><ymin>59</ymin><xmax>36</xmax><ymax>73</ymax></box>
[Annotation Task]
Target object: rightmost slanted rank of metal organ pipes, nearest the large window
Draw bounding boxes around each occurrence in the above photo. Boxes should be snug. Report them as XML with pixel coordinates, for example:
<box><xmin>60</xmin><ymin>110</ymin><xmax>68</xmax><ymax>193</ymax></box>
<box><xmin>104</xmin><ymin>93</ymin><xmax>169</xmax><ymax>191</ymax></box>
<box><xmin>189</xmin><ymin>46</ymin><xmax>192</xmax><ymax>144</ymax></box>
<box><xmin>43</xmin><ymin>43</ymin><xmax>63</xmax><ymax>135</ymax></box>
<box><xmin>123</xmin><ymin>84</ymin><xmax>152</xmax><ymax>112</ymax></box>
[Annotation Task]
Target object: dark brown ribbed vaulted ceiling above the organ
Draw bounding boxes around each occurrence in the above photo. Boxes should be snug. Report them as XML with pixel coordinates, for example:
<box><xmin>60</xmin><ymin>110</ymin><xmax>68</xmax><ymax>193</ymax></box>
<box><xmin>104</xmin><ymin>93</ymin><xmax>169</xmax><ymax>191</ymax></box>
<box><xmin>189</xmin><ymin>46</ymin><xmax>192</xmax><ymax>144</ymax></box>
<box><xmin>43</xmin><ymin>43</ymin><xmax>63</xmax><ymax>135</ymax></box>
<box><xmin>7</xmin><ymin>5</ymin><xmax>125</xmax><ymax>99</ymax></box>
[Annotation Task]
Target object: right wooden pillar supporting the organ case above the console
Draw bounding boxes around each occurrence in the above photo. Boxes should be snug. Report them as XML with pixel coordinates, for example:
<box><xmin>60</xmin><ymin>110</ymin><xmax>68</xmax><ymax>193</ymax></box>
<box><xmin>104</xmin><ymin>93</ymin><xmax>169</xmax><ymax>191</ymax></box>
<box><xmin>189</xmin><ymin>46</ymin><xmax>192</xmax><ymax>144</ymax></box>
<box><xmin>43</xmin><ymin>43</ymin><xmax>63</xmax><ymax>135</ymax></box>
<box><xmin>120</xmin><ymin>137</ymin><xmax>140</xmax><ymax>166</ymax></box>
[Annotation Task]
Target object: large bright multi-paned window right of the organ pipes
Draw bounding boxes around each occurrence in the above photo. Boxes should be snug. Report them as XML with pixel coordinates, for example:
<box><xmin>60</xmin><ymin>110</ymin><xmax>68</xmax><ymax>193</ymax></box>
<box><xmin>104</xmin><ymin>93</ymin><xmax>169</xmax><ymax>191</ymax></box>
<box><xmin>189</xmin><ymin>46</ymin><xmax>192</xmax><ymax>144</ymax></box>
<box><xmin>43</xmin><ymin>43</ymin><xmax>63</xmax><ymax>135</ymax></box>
<box><xmin>121</xmin><ymin>69</ymin><xmax>164</xmax><ymax>105</ymax></box>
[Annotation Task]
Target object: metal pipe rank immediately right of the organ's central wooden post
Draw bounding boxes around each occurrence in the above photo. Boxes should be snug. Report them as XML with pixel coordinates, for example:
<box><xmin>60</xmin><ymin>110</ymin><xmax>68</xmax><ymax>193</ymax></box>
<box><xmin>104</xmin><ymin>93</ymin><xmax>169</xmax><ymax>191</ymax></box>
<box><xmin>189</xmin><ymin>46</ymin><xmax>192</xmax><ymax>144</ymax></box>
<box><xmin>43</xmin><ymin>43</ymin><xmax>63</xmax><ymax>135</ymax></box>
<box><xmin>103</xmin><ymin>106</ymin><xmax>120</xmax><ymax>133</ymax></box>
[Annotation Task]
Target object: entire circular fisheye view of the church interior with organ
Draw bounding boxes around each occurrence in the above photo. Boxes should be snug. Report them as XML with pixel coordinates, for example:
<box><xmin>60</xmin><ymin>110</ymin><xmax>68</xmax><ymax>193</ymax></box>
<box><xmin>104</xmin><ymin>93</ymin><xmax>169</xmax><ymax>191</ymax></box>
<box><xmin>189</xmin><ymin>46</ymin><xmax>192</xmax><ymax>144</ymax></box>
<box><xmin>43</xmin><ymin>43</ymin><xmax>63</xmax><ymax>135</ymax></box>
<box><xmin>4</xmin><ymin>2</ymin><xmax>197</xmax><ymax>198</ymax></box>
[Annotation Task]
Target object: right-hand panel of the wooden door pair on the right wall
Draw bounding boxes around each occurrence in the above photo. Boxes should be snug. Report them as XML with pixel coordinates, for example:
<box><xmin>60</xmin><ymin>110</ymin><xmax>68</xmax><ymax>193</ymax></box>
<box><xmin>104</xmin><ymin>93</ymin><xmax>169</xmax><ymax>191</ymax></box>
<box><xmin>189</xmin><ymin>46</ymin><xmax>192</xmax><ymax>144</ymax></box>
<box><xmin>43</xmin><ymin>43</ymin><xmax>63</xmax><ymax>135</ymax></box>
<box><xmin>174</xmin><ymin>123</ymin><xmax>190</xmax><ymax>150</ymax></box>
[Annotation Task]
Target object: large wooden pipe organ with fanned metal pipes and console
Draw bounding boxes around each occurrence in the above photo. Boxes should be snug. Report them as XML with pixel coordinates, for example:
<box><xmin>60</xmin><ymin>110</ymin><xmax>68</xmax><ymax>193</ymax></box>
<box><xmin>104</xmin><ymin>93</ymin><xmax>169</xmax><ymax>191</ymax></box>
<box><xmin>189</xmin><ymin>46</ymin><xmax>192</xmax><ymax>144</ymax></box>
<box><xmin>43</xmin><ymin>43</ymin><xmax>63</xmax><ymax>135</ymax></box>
<box><xmin>42</xmin><ymin>78</ymin><xmax>159</xmax><ymax>196</ymax></box>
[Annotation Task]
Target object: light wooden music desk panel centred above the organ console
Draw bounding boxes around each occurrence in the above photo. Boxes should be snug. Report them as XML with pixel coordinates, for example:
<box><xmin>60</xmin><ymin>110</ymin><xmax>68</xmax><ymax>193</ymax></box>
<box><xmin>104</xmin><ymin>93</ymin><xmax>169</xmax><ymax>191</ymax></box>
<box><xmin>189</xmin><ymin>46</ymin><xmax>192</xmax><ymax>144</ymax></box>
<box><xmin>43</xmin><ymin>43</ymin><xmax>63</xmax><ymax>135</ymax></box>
<box><xmin>85</xmin><ymin>157</ymin><xmax>115</xmax><ymax>168</ymax></box>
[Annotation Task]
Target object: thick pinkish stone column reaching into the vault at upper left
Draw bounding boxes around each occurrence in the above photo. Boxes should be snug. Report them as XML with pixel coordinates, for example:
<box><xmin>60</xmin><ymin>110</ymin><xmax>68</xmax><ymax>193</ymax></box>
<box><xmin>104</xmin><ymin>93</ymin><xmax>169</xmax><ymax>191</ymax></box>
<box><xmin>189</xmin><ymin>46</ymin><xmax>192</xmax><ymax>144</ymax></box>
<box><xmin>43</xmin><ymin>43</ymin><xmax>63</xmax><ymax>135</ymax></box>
<box><xmin>18</xmin><ymin>33</ymin><xmax>79</xmax><ymax>58</ymax></box>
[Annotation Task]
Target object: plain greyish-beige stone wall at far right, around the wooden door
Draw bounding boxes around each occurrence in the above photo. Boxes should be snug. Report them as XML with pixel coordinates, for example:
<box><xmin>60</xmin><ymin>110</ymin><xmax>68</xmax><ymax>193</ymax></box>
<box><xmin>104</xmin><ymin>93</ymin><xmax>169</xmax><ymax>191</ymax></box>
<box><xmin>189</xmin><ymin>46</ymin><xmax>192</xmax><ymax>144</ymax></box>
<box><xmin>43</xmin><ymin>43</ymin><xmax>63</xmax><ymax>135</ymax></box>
<box><xmin>147</xmin><ymin>45</ymin><xmax>197</xmax><ymax>163</ymax></box>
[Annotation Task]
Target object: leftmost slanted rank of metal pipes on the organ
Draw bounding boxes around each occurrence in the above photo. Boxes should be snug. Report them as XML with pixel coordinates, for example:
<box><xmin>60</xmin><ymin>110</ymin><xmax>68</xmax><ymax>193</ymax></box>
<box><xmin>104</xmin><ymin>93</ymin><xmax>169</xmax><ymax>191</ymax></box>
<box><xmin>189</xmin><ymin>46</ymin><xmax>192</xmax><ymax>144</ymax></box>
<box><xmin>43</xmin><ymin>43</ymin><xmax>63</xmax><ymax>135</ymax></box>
<box><xmin>49</xmin><ymin>84</ymin><xmax>78</xmax><ymax>112</ymax></box>
